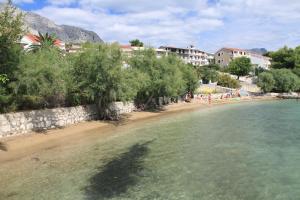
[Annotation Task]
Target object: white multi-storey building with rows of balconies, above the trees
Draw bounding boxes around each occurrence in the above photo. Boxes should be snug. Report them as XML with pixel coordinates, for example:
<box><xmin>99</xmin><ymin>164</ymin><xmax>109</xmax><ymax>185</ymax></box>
<box><xmin>159</xmin><ymin>45</ymin><xmax>210</xmax><ymax>66</ymax></box>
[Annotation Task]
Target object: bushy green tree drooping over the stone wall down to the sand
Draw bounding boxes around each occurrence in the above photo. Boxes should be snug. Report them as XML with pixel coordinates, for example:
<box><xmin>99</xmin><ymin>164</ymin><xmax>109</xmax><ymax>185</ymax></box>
<box><xmin>72</xmin><ymin>44</ymin><xmax>134</xmax><ymax>119</ymax></box>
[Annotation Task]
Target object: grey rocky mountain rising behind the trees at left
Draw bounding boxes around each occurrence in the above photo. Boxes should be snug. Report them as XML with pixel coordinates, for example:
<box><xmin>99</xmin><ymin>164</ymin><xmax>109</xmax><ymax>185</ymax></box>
<box><xmin>0</xmin><ymin>3</ymin><xmax>103</xmax><ymax>43</ymax></box>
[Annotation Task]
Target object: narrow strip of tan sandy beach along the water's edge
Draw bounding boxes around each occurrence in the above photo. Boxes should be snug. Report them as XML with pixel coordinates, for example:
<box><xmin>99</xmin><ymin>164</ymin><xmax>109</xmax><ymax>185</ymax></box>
<box><xmin>0</xmin><ymin>97</ymin><xmax>278</xmax><ymax>164</ymax></box>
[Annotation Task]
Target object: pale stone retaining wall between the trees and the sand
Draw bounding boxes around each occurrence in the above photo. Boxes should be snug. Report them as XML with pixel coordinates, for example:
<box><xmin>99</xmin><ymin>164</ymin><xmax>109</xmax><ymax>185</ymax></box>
<box><xmin>0</xmin><ymin>102</ymin><xmax>135</xmax><ymax>137</ymax></box>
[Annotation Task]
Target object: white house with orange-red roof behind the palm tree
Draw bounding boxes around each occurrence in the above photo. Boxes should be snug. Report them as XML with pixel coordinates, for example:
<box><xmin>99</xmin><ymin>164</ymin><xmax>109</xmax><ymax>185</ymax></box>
<box><xmin>20</xmin><ymin>34</ymin><xmax>66</xmax><ymax>51</ymax></box>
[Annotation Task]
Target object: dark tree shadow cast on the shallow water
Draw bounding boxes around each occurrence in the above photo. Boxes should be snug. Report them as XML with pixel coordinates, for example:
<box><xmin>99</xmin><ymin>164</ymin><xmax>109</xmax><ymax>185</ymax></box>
<box><xmin>84</xmin><ymin>141</ymin><xmax>153</xmax><ymax>200</ymax></box>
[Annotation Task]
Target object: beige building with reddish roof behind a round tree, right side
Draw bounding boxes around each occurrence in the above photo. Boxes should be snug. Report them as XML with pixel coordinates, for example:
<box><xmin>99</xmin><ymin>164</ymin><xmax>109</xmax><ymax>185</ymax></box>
<box><xmin>215</xmin><ymin>48</ymin><xmax>271</xmax><ymax>69</ymax></box>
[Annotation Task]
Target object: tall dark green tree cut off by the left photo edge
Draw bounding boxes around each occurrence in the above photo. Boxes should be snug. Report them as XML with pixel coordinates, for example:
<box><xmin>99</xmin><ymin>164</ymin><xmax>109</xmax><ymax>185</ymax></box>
<box><xmin>0</xmin><ymin>1</ymin><xmax>23</xmax><ymax>112</ymax></box>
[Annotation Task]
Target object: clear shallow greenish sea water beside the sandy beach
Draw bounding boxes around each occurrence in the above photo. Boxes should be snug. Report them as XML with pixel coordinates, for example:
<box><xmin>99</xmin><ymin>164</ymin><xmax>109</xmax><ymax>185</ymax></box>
<box><xmin>0</xmin><ymin>101</ymin><xmax>300</xmax><ymax>200</ymax></box>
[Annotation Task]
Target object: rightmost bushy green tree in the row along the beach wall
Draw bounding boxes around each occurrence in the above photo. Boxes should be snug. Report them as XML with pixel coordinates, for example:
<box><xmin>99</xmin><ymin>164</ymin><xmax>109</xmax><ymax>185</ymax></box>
<box><xmin>130</xmin><ymin>49</ymin><xmax>192</xmax><ymax>107</ymax></box>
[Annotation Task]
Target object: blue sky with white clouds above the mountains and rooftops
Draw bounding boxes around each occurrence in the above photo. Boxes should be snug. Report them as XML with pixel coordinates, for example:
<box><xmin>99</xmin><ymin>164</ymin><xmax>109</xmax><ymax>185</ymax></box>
<box><xmin>0</xmin><ymin>0</ymin><xmax>300</xmax><ymax>53</ymax></box>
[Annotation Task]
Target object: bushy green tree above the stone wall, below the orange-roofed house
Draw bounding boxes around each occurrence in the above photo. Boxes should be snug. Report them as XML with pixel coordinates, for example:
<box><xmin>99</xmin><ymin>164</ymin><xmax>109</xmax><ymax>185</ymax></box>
<box><xmin>10</xmin><ymin>49</ymin><xmax>69</xmax><ymax>109</ymax></box>
